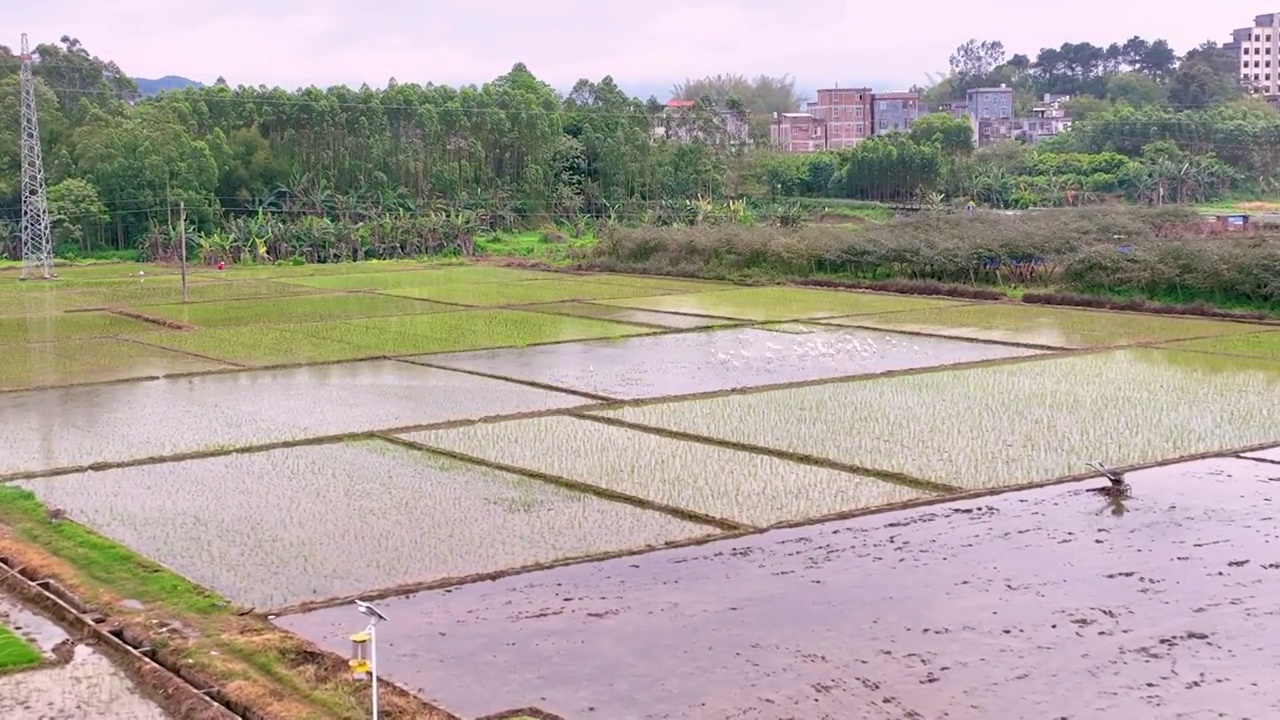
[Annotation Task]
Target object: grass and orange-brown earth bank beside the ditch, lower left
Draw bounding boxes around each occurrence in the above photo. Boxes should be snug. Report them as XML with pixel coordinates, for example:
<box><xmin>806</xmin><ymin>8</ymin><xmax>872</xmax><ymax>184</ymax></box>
<box><xmin>0</xmin><ymin>486</ymin><xmax>448</xmax><ymax>720</ymax></box>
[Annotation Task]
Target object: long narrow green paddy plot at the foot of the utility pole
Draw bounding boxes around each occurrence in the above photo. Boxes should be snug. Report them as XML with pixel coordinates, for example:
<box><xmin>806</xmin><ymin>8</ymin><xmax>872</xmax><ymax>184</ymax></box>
<box><xmin>144</xmin><ymin>293</ymin><xmax>457</xmax><ymax>325</ymax></box>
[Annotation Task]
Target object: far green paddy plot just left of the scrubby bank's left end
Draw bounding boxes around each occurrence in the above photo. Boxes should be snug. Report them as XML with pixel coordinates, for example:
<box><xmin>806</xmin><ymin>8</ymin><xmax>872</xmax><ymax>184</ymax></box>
<box><xmin>387</xmin><ymin>278</ymin><xmax>662</xmax><ymax>307</ymax></box>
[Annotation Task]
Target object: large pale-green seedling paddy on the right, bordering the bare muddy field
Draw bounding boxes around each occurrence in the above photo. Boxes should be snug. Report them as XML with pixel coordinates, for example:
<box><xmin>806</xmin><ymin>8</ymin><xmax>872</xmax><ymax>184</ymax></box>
<box><xmin>602</xmin><ymin>348</ymin><xmax>1280</xmax><ymax>488</ymax></box>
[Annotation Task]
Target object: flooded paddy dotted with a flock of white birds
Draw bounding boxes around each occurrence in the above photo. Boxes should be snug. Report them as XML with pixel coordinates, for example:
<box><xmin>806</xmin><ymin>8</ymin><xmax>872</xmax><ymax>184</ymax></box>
<box><xmin>428</xmin><ymin>328</ymin><xmax>1038</xmax><ymax>400</ymax></box>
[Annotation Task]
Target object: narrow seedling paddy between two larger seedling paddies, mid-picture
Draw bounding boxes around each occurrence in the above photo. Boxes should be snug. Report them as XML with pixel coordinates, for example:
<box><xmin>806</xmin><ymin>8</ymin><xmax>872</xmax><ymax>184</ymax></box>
<box><xmin>406</xmin><ymin>418</ymin><xmax>925</xmax><ymax>527</ymax></box>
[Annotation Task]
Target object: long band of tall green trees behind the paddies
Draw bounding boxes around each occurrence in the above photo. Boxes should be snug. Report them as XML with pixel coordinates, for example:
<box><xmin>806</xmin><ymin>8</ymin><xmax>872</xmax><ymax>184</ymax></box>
<box><xmin>0</xmin><ymin>37</ymin><xmax>1280</xmax><ymax>259</ymax></box>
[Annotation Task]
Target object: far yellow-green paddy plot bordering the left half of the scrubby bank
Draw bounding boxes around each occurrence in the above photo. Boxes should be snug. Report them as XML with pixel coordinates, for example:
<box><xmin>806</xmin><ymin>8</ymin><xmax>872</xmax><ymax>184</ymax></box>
<box><xmin>600</xmin><ymin>287</ymin><xmax>957</xmax><ymax>322</ymax></box>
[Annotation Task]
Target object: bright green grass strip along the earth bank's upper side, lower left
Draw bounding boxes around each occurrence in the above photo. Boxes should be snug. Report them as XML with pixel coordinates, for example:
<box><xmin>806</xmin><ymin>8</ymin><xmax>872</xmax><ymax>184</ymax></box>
<box><xmin>0</xmin><ymin>486</ymin><xmax>225</xmax><ymax>615</ymax></box>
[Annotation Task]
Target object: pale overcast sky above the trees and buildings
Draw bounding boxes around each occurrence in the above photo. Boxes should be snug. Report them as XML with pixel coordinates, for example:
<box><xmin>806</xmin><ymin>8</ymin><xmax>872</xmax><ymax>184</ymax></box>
<box><xmin>0</xmin><ymin>0</ymin><xmax>1280</xmax><ymax>92</ymax></box>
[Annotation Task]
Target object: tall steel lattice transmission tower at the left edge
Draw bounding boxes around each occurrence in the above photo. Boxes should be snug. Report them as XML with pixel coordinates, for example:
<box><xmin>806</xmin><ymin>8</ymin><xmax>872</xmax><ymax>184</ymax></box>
<box><xmin>22</xmin><ymin>33</ymin><xmax>54</xmax><ymax>279</ymax></box>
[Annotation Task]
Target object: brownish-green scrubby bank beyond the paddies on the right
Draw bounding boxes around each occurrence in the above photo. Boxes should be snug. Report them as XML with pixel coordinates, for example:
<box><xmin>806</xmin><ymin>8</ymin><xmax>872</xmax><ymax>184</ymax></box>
<box><xmin>579</xmin><ymin>208</ymin><xmax>1280</xmax><ymax>316</ymax></box>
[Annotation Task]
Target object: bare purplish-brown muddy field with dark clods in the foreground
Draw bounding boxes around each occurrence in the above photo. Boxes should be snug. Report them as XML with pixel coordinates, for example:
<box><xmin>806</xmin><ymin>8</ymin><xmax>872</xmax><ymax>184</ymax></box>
<box><xmin>279</xmin><ymin>459</ymin><xmax>1280</xmax><ymax>720</ymax></box>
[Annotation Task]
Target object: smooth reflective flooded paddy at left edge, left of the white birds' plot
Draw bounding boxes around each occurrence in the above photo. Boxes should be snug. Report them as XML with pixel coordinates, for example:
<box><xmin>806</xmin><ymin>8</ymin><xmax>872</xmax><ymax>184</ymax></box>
<box><xmin>0</xmin><ymin>360</ymin><xmax>585</xmax><ymax>474</ymax></box>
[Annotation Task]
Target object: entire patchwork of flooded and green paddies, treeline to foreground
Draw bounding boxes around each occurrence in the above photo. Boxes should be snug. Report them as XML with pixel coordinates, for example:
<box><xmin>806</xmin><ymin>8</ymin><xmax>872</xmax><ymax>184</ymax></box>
<box><xmin>0</xmin><ymin>263</ymin><xmax>1280</xmax><ymax>719</ymax></box>
